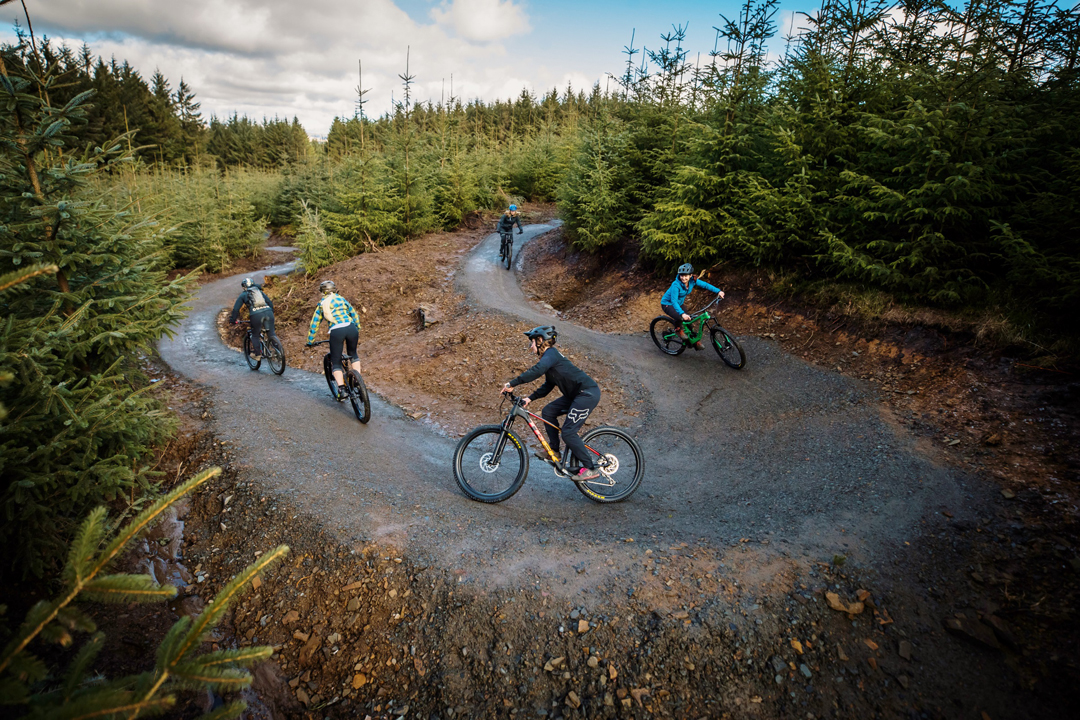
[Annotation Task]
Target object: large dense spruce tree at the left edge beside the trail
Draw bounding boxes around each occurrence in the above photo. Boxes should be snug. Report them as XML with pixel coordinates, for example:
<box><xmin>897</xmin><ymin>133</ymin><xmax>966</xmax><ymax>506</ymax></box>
<box><xmin>0</xmin><ymin>46</ymin><xmax>190</xmax><ymax>574</ymax></box>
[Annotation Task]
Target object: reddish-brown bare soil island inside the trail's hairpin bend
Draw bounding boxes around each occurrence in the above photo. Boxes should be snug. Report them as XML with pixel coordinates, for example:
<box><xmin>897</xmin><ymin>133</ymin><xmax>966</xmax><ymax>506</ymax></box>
<box><xmin>218</xmin><ymin>207</ymin><xmax>637</xmax><ymax>436</ymax></box>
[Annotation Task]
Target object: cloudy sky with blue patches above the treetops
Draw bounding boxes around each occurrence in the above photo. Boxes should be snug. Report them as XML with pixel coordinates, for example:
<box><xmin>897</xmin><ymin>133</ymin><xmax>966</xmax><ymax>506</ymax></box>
<box><xmin>0</xmin><ymin>0</ymin><xmax>816</xmax><ymax>135</ymax></box>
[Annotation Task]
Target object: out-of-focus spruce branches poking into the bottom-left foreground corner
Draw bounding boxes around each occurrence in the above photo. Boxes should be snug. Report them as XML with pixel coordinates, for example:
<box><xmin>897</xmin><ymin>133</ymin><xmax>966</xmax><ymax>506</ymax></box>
<box><xmin>0</xmin><ymin>467</ymin><xmax>288</xmax><ymax>720</ymax></box>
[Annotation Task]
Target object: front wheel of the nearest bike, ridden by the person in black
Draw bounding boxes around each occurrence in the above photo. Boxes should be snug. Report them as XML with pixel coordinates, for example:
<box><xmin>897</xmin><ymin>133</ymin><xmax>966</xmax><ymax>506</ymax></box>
<box><xmin>454</xmin><ymin>425</ymin><xmax>529</xmax><ymax>503</ymax></box>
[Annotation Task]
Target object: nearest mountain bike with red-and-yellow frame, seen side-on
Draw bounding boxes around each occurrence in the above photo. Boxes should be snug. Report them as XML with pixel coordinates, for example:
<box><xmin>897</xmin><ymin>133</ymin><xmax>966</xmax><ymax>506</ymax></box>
<box><xmin>454</xmin><ymin>393</ymin><xmax>645</xmax><ymax>503</ymax></box>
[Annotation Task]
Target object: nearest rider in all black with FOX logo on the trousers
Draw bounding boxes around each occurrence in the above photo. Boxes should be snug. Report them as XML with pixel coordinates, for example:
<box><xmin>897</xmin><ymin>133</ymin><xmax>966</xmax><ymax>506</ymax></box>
<box><xmin>502</xmin><ymin>325</ymin><xmax>600</xmax><ymax>481</ymax></box>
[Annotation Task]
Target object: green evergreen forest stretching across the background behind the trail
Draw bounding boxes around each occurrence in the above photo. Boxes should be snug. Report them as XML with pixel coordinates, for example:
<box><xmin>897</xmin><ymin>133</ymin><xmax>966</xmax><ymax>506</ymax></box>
<box><xmin>0</xmin><ymin>0</ymin><xmax>1080</xmax><ymax>595</ymax></box>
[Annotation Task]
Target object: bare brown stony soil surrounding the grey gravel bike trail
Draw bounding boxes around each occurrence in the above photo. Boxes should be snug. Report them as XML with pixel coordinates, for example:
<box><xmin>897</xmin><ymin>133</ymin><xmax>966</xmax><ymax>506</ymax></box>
<box><xmin>107</xmin><ymin>216</ymin><xmax>1080</xmax><ymax>720</ymax></box>
